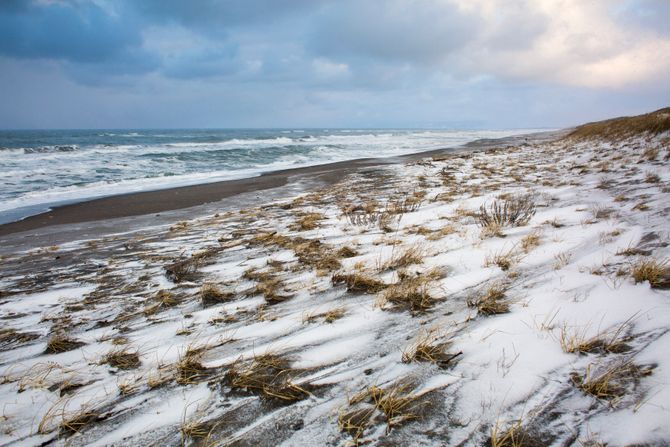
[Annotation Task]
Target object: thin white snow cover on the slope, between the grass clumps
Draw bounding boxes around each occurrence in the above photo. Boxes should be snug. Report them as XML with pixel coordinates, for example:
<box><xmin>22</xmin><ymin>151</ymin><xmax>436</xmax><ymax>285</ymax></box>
<box><xmin>0</xmin><ymin>131</ymin><xmax>670</xmax><ymax>446</ymax></box>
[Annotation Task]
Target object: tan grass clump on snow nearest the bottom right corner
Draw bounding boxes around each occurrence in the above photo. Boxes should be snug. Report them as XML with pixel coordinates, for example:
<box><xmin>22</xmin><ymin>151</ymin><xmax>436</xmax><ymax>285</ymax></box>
<box><xmin>570</xmin><ymin>360</ymin><xmax>653</xmax><ymax>404</ymax></box>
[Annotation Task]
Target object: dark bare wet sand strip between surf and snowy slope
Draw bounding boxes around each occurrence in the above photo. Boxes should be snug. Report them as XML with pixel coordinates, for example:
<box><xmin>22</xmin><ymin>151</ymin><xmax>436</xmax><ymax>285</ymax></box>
<box><xmin>0</xmin><ymin>130</ymin><xmax>565</xmax><ymax>237</ymax></box>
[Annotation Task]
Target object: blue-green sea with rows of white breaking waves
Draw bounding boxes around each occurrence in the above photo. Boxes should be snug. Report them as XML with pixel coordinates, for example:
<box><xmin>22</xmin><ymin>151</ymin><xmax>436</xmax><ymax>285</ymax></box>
<box><xmin>0</xmin><ymin>129</ymin><xmax>545</xmax><ymax>224</ymax></box>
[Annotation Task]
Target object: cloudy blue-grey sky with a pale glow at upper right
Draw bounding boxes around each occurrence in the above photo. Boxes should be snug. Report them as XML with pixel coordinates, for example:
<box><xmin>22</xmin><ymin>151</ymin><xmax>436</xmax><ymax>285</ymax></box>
<box><xmin>0</xmin><ymin>0</ymin><xmax>670</xmax><ymax>129</ymax></box>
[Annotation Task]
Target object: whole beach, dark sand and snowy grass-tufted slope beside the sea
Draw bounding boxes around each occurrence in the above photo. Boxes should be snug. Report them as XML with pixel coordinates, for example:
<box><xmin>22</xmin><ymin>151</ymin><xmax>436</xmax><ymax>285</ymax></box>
<box><xmin>0</xmin><ymin>111</ymin><xmax>670</xmax><ymax>446</ymax></box>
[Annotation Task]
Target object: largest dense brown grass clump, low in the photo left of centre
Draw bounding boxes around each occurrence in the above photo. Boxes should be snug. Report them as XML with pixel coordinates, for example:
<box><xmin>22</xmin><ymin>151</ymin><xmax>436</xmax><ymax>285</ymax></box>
<box><xmin>226</xmin><ymin>353</ymin><xmax>310</xmax><ymax>403</ymax></box>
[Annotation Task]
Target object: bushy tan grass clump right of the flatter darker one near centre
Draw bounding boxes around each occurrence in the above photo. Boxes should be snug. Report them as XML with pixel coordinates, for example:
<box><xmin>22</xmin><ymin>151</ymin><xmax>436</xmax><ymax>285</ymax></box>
<box><xmin>377</xmin><ymin>275</ymin><xmax>435</xmax><ymax>312</ymax></box>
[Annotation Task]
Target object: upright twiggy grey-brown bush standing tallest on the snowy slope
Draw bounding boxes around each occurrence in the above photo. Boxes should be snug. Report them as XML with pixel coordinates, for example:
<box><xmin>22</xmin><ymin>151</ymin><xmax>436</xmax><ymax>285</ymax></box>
<box><xmin>476</xmin><ymin>194</ymin><xmax>537</xmax><ymax>228</ymax></box>
